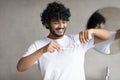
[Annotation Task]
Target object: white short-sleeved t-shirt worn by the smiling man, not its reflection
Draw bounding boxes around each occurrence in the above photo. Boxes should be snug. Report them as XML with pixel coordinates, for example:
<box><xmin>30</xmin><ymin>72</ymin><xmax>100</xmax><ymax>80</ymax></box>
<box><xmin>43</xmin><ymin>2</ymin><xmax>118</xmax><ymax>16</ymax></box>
<box><xmin>24</xmin><ymin>35</ymin><xmax>94</xmax><ymax>80</ymax></box>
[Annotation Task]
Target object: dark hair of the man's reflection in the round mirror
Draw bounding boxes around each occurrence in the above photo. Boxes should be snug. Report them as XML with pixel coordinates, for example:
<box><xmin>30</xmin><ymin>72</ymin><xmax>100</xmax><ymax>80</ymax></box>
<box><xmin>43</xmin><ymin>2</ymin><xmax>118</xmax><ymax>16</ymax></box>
<box><xmin>86</xmin><ymin>11</ymin><xmax>106</xmax><ymax>29</ymax></box>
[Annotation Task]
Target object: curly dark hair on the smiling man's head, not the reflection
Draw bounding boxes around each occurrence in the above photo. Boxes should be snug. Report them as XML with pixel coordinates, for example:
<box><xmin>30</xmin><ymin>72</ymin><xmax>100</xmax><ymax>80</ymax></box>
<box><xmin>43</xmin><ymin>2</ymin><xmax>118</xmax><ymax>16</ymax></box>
<box><xmin>40</xmin><ymin>1</ymin><xmax>71</xmax><ymax>29</ymax></box>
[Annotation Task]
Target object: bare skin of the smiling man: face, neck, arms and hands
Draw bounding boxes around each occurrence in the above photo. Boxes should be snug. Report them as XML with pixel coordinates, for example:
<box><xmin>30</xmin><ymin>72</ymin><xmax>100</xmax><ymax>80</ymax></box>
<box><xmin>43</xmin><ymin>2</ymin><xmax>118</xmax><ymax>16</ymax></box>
<box><xmin>17</xmin><ymin>19</ymin><xmax>110</xmax><ymax>72</ymax></box>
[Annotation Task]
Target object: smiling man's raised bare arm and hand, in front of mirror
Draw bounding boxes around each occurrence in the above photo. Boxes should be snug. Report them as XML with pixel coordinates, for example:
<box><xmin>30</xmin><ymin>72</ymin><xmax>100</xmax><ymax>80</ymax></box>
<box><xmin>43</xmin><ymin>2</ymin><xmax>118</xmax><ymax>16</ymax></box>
<box><xmin>79</xmin><ymin>29</ymin><xmax>111</xmax><ymax>44</ymax></box>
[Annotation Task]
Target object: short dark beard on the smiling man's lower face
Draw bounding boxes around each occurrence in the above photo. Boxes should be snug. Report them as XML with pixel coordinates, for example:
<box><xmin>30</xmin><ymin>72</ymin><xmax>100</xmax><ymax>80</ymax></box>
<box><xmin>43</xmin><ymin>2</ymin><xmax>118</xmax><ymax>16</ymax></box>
<box><xmin>49</xmin><ymin>27</ymin><xmax>66</xmax><ymax>37</ymax></box>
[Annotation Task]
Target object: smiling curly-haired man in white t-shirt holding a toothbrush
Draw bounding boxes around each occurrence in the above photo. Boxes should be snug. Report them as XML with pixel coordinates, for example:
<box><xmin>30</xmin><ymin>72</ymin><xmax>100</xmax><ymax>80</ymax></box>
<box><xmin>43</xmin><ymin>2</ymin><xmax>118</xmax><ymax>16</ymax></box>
<box><xmin>17</xmin><ymin>2</ymin><xmax>110</xmax><ymax>80</ymax></box>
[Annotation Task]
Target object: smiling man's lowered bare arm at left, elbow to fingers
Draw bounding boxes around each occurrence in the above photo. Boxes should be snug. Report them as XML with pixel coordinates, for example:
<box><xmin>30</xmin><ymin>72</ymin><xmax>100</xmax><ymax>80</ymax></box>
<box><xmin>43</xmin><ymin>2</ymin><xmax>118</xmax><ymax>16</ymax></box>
<box><xmin>17</xmin><ymin>42</ymin><xmax>60</xmax><ymax>72</ymax></box>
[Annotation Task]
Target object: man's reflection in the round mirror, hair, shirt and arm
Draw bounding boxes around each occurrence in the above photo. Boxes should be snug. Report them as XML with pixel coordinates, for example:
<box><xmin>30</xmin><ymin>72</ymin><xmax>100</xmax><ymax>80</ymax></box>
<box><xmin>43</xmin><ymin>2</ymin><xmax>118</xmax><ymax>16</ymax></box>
<box><xmin>86</xmin><ymin>11</ymin><xmax>120</xmax><ymax>54</ymax></box>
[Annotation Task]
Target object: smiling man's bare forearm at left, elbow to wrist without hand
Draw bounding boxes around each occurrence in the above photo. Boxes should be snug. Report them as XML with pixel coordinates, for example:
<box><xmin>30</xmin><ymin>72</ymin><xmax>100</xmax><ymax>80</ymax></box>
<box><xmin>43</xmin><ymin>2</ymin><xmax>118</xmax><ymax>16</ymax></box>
<box><xmin>17</xmin><ymin>49</ymin><xmax>44</xmax><ymax>72</ymax></box>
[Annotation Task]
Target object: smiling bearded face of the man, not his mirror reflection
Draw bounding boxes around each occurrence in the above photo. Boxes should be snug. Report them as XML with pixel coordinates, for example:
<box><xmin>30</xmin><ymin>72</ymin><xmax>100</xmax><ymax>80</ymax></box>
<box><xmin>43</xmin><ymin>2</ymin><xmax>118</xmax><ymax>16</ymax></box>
<box><xmin>49</xmin><ymin>19</ymin><xmax>67</xmax><ymax>38</ymax></box>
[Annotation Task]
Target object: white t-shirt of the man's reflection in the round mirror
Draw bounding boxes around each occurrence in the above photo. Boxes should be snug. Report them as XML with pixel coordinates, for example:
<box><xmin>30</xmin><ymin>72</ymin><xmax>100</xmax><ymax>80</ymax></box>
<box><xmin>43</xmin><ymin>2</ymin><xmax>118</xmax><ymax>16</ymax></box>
<box><xmin>94</xmin><ymin>32</ymin><xmax>116</xmax><ymax>54</ymax></box>
